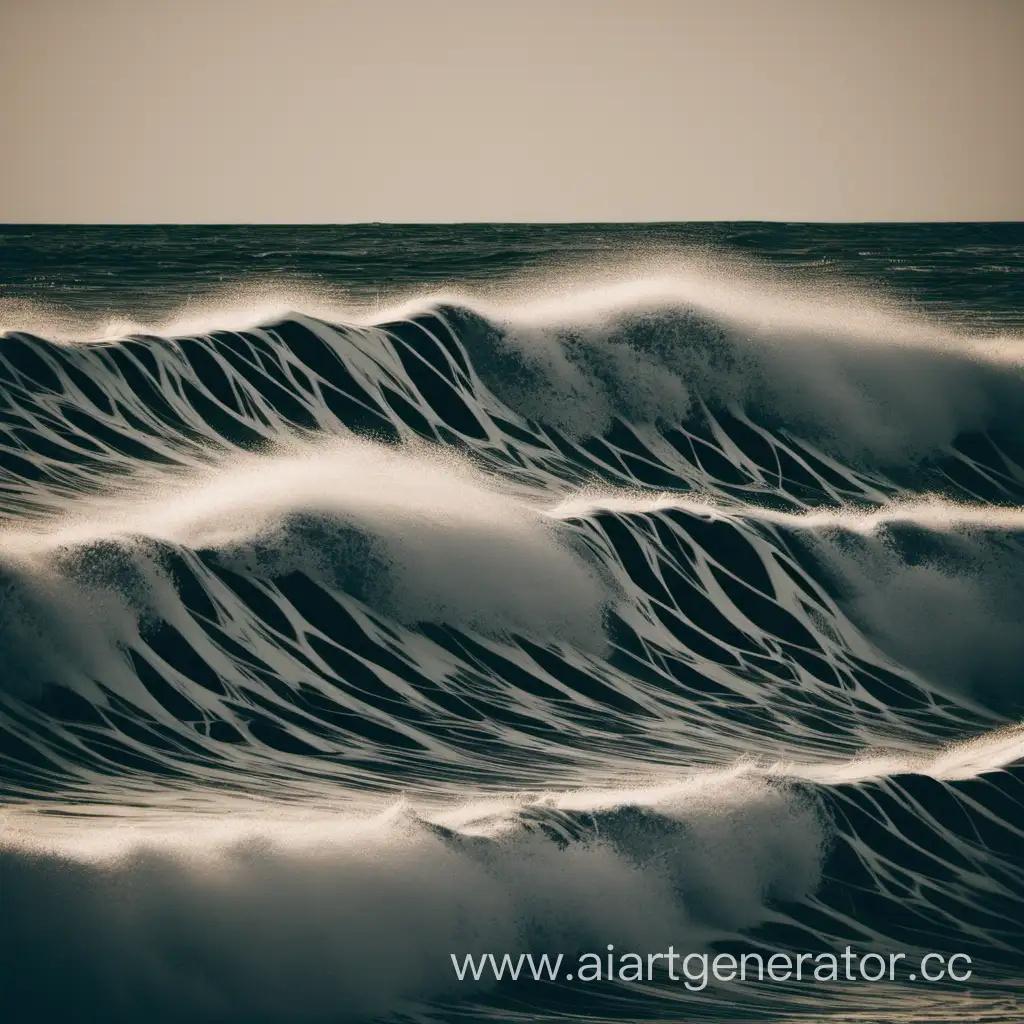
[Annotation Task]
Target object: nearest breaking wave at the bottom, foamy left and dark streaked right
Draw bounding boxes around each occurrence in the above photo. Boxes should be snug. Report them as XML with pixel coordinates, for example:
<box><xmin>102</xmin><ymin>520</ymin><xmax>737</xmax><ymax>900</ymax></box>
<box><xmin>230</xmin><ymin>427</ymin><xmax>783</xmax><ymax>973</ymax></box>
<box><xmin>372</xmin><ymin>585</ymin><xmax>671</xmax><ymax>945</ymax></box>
<box><xmin>0</xmin><ymin>757</ymin><xmax>1024</xmax><ymax>1021</ymax></box>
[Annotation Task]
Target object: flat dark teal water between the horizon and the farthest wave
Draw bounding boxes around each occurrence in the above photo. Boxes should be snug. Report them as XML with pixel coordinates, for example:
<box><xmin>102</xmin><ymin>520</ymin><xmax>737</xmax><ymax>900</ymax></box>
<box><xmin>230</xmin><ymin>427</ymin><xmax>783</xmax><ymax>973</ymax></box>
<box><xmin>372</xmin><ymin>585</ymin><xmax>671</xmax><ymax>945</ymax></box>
<box><xmin>6</xmin><ymin>223</ymin><xmax>1024</xmax><ymax>331</ymax></box>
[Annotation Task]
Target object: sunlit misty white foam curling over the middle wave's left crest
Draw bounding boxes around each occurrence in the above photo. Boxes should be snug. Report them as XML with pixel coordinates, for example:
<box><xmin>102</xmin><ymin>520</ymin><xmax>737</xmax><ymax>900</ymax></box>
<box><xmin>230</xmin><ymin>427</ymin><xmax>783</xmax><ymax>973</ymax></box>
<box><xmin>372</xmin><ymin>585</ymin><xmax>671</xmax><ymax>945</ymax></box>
<box><xmin>0</xmin><ymin>439</ymin><xmax>607</xmax><ymax>646</ymax></box>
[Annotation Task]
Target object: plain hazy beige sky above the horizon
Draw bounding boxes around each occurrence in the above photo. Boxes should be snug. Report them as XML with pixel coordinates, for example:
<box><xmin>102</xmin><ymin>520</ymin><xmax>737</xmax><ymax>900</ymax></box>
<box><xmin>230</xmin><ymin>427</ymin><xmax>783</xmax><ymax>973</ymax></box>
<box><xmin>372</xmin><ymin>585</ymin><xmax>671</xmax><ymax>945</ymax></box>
<box><xmin>0</xmin><ymin>0</ymin><xmax>1024</xmax><ymax>223</ymax></box>
